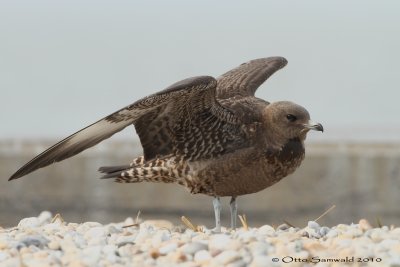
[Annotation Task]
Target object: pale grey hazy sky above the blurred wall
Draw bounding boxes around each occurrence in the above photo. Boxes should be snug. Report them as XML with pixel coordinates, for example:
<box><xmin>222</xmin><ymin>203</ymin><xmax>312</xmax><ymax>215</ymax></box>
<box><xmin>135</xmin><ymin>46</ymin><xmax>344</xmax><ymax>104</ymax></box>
<box><xmin>0</xmin><ymin>0</ymin><xmax>400</xmax><ymax>140</ymax></box>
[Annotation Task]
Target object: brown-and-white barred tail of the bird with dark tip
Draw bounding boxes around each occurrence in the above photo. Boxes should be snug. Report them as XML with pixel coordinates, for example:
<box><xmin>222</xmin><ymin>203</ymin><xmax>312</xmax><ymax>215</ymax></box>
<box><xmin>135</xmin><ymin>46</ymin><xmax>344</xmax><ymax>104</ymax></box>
<box><xmin>99</xmin><ymin>157</ymin><xmax>176</xmax><ymax>183</ymax></box>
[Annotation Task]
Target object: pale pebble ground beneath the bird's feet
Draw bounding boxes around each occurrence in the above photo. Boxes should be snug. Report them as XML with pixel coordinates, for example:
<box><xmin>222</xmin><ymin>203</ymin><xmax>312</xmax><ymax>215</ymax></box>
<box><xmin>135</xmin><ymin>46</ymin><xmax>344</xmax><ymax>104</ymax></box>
<box><xmin>0</xmin><ymin>212</ymin><xmax>400</xmax><ymax>267</ymax></box>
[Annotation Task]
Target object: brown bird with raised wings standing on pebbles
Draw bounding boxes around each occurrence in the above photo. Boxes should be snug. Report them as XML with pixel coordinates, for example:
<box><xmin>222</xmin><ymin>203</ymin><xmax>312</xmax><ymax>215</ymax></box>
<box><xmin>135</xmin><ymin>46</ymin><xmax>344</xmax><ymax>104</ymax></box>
<box><xmin>9</xmin><ymin>57</ymin><xmax>323</xmax><ymax>232</ymax></box>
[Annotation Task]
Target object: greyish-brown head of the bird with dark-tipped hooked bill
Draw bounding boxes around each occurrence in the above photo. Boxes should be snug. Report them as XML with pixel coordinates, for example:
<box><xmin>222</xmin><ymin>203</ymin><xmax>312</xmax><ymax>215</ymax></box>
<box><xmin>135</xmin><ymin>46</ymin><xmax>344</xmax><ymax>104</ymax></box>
<box><xmin>264</xmin><ymin>101</ymin><xmax>324</xmax><ymax>146</ymax></box>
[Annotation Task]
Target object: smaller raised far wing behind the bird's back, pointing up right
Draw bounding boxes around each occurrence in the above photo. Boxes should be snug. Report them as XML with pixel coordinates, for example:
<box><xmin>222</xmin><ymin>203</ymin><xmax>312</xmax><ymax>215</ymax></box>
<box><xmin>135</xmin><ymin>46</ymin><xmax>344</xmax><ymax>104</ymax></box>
<box><xmin>217</xmin><ymin>57</ymin><xmax>287</xmax><ymax>99</ymax></box>
